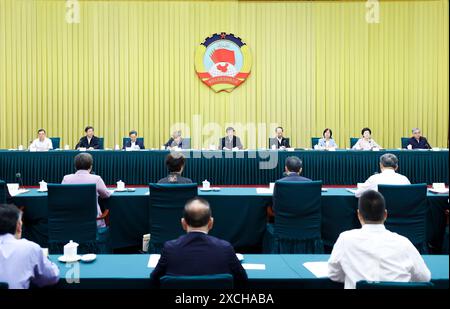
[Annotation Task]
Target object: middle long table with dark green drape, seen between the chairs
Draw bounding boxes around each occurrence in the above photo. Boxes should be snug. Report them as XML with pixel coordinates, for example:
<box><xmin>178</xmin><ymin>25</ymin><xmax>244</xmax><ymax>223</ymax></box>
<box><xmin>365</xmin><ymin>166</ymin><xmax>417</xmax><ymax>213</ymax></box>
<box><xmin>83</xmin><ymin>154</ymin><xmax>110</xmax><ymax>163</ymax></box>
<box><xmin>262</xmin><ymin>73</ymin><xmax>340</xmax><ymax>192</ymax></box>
<box><xmin>14</xmin><ymin>188</ymin><xmax>449</xmax><ymax>253</ymax></box>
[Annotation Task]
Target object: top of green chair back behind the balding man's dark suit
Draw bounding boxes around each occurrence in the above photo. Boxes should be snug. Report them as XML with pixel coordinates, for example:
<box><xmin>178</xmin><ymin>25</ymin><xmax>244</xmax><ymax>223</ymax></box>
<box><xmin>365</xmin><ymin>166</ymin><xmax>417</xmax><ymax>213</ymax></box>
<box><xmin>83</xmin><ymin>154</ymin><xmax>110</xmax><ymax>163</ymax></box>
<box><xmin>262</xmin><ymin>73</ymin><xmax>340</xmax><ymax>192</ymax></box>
<box><xmin>160</xmin><ymin>274</ymin><xmax>233</xmax><ymax>289</ymax></box>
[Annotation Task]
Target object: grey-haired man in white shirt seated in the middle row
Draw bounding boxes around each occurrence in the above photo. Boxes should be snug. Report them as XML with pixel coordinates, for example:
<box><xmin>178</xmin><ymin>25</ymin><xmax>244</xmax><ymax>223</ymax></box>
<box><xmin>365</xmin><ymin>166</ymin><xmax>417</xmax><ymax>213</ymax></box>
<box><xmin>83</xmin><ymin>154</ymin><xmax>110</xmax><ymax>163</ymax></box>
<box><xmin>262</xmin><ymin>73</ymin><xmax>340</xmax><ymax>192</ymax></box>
<box><xmin>355</xmin><ymin>153</ymin><xmax>411</xmax><ymax>197</ymax></box>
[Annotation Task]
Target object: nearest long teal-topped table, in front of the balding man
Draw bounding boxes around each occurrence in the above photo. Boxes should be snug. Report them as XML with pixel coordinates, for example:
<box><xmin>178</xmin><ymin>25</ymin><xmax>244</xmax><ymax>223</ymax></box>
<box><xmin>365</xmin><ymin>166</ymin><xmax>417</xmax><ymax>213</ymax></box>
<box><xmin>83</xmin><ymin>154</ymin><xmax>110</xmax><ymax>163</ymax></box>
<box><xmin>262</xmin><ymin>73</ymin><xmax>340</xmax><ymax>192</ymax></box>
<box><xmin>50</xmin><ymin>254</ymin><xmax>449</xmax><ymax>289</ymax></box>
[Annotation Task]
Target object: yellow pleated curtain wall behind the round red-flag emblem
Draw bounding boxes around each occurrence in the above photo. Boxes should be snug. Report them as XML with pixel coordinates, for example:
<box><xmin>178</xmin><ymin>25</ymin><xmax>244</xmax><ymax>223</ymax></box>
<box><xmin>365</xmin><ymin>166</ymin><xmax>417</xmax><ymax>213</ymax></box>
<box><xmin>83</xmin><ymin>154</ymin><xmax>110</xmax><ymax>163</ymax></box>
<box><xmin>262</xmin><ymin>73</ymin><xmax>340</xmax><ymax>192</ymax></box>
<box><xmin>0</xmin><ymin>0</ymin><xmax>449</xmax><ymax>148</ymax></box>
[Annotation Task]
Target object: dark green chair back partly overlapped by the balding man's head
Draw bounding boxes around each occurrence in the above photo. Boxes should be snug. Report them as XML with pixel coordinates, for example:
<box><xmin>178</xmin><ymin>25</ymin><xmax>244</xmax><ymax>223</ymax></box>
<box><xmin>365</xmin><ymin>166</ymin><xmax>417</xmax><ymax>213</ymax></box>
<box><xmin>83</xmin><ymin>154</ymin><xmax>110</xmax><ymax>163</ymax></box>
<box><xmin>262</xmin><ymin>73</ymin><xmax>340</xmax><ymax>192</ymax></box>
<box><xmin>149</xmin><ymin>183</ymin><xmax>197</xmax><ymax>253</ymax></box>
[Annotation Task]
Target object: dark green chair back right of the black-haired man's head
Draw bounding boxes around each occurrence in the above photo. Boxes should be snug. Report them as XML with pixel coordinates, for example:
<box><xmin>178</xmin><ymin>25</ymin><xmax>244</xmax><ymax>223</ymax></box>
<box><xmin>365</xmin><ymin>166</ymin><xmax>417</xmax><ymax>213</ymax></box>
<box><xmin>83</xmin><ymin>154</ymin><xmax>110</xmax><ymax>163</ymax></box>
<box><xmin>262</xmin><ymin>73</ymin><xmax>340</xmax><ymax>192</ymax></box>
<box><xmin>378</xmin><ymin>183</ymin><xmax>427</xmax><ymax>251</ymax></box>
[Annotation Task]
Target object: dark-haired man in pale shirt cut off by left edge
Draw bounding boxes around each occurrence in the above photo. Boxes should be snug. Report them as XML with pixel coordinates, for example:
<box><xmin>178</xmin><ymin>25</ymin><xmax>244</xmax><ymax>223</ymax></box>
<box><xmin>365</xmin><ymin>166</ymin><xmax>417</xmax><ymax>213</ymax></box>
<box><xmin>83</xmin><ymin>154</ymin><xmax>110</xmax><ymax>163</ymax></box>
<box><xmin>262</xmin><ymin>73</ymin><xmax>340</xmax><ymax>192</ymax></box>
<box><xmin>0</xmin><ymin>204</ymin><xmax>59</xmax><ymax>289</ymax></box>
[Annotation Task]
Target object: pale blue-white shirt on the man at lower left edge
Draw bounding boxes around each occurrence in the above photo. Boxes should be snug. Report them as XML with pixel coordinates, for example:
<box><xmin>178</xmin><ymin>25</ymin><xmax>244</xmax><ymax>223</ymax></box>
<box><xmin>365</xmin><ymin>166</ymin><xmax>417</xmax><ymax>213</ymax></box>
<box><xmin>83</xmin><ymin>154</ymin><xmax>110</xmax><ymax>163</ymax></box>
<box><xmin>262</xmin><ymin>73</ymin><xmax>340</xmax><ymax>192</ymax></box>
<box><xmin>0</xmin><ymin>234</ymin><xmax>59</xmax><ymax>289</ymax></box>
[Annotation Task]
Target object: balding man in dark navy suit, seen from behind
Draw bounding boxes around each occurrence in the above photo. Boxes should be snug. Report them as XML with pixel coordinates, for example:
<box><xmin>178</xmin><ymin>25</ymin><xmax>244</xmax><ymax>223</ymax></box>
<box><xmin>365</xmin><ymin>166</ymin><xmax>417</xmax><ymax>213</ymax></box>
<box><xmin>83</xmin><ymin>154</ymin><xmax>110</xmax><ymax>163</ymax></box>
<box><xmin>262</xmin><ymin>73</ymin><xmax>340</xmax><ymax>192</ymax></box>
<box><xmin>150</xmin><ymin>197</ymin><xmax>248</xmax><ymax>286</ymax></box>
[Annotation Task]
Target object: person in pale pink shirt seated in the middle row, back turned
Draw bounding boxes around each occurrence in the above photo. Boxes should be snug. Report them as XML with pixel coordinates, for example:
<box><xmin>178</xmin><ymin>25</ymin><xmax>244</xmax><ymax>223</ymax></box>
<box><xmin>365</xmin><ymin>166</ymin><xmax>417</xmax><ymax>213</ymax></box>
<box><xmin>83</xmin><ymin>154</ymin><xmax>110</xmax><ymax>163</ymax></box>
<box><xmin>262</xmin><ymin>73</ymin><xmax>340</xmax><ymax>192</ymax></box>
<box><xmin>61</xmin><ymin>152</ymin><xmax>111</xmax><ymax>227</ymax></box>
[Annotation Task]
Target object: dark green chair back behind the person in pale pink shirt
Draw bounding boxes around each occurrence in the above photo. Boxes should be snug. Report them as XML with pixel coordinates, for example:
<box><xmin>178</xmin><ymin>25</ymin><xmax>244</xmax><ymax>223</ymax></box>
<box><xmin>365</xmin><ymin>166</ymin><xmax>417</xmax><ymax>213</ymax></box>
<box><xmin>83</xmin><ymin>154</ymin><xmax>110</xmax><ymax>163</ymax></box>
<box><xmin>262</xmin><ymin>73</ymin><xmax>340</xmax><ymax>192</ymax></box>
<box><xmin>48</xmin><ymin>184</ymin><xmax>97</xmax><ymax>244</ymax></box>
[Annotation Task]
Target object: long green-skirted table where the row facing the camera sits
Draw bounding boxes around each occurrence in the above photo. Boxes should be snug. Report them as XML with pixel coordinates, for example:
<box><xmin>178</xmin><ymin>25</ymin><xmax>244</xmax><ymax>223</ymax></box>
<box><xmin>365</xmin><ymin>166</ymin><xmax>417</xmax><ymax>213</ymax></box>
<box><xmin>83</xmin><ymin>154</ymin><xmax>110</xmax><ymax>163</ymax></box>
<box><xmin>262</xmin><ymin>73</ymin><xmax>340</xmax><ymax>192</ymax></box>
<box><xmin>0</xmin><ymin>149</ymin><xmax>449</xmax><ymax>186</ymax></box>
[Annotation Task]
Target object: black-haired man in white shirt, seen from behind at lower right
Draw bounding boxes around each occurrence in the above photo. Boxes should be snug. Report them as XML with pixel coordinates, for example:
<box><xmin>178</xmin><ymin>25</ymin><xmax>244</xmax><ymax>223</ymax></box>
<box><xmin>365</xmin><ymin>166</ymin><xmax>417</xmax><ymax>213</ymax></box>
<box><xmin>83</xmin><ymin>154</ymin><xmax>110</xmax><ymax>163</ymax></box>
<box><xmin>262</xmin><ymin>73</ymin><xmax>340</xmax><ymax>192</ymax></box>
<box><xmin>328</xmin><ymin>190</ymin><xmax>431</xmax><ymax>289</ymax></box>
